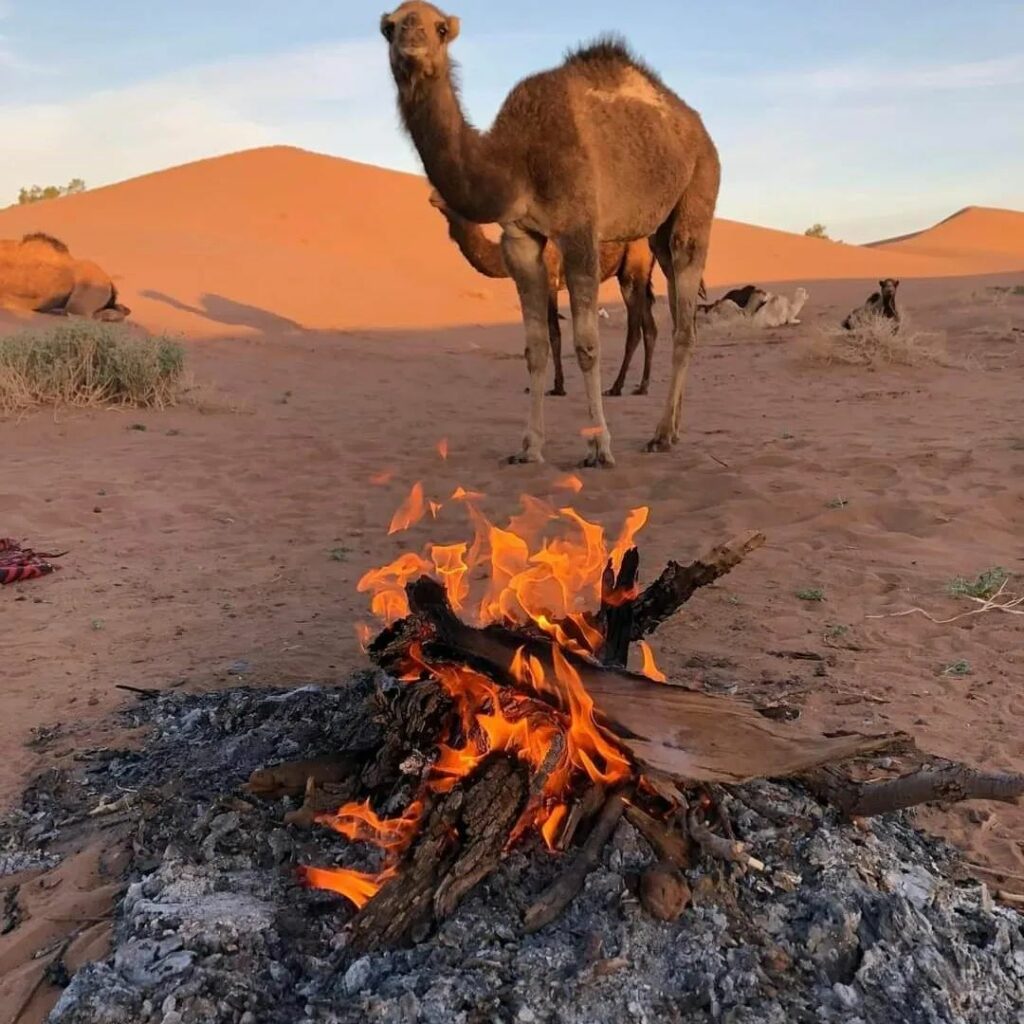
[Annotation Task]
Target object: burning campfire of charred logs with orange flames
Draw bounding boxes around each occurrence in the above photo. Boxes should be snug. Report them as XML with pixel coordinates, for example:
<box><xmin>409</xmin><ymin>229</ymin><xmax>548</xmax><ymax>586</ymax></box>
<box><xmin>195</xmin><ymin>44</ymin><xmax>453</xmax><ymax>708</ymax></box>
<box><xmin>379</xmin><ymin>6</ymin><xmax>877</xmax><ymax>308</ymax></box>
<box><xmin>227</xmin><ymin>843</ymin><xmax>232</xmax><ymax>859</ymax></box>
<box><xmin>247</xmin><ymin>483</ymin><xmax>1021</xmax><ymax>949</ymax></box>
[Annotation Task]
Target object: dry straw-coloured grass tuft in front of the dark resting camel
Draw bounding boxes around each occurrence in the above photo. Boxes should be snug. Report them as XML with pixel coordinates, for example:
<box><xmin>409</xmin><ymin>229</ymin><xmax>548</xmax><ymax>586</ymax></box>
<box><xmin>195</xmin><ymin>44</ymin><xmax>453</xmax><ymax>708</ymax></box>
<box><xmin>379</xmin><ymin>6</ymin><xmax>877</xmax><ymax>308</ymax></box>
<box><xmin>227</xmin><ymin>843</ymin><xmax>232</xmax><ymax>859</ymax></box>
<box><xmin>807</xmin><ymin>315</ymin><xmax>953</xmax><ymax>367</ymax></box>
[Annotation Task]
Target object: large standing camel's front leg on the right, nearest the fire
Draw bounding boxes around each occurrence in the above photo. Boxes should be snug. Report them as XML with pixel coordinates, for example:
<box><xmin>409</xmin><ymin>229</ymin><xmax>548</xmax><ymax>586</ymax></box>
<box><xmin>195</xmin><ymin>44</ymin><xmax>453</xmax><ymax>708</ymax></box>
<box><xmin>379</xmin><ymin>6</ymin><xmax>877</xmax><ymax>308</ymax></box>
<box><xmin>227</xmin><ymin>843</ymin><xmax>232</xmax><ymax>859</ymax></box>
<box><xmin>559</xmin><ymin>231</ymin><xmax>615</xmax><ymax>466</ymax></box>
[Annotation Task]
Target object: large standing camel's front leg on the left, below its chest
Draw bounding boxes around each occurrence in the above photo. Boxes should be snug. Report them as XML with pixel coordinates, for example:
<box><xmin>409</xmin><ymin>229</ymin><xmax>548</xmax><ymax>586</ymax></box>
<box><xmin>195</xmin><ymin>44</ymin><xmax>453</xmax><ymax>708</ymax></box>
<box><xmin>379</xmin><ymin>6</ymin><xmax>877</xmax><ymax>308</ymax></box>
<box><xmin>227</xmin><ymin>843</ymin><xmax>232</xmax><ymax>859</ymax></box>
<box><xmin>502</xmin><ymin>226</ymin><xmax>551</xmax><ymax>463</ymax></box>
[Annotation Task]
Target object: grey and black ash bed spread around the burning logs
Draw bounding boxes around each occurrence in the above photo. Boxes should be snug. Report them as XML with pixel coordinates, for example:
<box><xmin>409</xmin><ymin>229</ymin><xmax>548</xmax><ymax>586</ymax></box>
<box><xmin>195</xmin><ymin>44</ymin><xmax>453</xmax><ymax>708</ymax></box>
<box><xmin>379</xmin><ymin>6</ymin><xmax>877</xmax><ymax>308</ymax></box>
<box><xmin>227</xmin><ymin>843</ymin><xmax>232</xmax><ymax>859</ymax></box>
<box><xmin>8</xmin><ymin>674</ymin><xmax>1024</xmax><ymax>1024</ymax></box>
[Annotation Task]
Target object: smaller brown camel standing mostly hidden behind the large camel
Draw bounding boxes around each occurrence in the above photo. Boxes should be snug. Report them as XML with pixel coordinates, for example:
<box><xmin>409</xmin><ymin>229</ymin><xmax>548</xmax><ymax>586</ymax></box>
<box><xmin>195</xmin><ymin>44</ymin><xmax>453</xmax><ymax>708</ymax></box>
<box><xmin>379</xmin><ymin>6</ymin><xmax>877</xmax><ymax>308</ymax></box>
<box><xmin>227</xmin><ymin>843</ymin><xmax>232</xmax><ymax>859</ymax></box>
<box><xmin>430</xmin><ymin>189</ymin><xmax>657</xmax><ymax>396</ymax></box>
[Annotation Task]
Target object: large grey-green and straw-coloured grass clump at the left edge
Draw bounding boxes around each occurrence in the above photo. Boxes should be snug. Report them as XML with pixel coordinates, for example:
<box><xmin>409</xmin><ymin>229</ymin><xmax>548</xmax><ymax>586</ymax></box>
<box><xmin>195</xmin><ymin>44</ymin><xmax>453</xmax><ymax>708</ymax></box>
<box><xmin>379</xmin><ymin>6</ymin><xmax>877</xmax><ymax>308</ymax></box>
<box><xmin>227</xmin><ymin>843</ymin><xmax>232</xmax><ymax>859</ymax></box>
<box><xmin>0</xmin><ymin>321</ymin><xmax>185</xmax><ymax>413</ymax></box>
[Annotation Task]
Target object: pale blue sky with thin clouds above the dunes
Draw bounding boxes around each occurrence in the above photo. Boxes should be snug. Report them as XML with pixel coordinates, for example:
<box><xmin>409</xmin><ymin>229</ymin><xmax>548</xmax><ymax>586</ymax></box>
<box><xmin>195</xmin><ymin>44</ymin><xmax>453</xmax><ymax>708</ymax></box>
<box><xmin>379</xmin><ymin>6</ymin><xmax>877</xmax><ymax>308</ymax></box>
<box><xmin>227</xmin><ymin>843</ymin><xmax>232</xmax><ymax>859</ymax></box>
<box><xmin>0</xmin><ymin>0</ymin><xmax>1024</xmax><ymax>242</ymax></box>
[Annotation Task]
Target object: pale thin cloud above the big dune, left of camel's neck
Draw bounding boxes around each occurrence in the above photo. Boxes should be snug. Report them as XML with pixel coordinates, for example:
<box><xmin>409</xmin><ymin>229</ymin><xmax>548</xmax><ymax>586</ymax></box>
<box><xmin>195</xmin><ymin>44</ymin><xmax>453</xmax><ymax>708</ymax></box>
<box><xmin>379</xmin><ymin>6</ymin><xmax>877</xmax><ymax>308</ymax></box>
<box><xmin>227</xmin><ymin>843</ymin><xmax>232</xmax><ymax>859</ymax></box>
<box><xmin>0</xmin><ymin>38</ymin><xmax>395</xmax><ymax>205</ymax></box>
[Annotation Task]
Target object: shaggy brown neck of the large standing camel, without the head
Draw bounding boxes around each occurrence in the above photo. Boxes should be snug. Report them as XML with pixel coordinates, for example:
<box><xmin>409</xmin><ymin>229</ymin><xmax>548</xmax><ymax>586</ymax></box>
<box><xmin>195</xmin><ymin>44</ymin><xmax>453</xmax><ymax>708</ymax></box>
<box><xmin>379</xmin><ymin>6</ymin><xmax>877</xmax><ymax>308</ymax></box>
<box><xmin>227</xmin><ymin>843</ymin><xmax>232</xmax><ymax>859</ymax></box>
<box><xmin>398</xmin><ymin>75</ymin><xmax>515</xmax><ymax>226</ymax></box>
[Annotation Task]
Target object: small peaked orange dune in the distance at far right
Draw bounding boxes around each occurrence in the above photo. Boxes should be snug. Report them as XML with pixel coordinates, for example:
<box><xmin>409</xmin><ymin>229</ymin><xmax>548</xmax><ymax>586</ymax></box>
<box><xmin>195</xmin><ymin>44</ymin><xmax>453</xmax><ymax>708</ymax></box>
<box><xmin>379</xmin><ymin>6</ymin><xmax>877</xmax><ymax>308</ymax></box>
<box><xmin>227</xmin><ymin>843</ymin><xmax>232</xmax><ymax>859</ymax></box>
<box><xmin>872</xmin><ymin>206</ymin><xmax>1024</xmax><ymax>269</ymax></box>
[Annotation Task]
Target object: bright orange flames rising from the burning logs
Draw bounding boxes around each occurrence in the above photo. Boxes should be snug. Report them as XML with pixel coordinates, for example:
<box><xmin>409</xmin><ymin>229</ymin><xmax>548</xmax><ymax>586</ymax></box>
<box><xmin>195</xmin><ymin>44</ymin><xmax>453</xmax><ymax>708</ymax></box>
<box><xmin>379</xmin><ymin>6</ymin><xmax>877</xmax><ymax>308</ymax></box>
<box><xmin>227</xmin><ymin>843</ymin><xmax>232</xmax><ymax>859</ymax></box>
<box><xmin>305</xmin><ymin>491</ymin><xmax>665</xmax><ymax>906</ymax></box>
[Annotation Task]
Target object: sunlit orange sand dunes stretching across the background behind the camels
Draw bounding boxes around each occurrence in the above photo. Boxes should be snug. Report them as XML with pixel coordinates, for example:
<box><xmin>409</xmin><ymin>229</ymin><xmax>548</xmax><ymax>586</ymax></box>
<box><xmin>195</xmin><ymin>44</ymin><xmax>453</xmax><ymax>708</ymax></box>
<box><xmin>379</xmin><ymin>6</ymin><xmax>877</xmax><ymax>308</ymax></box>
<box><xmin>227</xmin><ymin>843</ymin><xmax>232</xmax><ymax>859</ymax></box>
<box><xmin>0</xmin><ymin>146</ymin><xmax>1024</xmax><ymax>338</ymax></box>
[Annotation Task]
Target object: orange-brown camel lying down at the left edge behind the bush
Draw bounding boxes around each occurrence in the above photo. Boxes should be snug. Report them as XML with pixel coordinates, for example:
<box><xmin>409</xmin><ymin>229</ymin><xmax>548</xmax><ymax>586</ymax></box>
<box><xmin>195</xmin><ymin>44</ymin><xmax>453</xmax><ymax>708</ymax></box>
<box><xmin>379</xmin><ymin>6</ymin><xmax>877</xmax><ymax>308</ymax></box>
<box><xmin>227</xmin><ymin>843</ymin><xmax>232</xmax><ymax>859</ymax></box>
<box><xmin>0</xmin><ymin>231</ymin><xmax>131</xmax><ymax>321</ymax></box>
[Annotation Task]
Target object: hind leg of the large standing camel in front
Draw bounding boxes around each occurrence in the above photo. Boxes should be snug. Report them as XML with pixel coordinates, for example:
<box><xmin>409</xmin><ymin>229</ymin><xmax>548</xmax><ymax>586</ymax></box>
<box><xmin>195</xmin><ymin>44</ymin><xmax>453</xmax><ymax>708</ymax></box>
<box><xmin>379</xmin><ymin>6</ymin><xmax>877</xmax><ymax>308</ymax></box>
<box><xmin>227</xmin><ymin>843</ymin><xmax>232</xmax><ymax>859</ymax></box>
<box><xmin>647</xmin><ymin>188</ymin><xmax>714</xmax><ymax>452</ymax></box>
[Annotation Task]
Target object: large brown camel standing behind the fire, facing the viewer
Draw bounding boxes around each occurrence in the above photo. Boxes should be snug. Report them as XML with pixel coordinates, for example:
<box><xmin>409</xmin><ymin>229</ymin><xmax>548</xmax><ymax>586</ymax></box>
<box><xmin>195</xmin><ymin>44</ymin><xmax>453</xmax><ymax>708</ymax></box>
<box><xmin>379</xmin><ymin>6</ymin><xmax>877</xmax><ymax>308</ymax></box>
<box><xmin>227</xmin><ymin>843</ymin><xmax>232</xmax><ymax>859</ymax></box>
<box><xmin>381</xmin><ymin>0</ymin><xmax>721</xmax><ymax>465</ymax></box>
